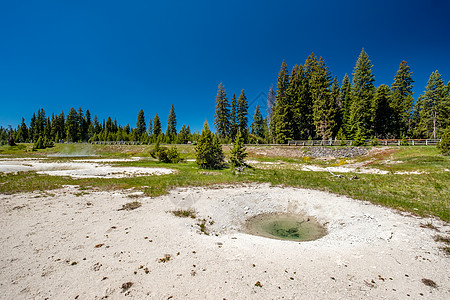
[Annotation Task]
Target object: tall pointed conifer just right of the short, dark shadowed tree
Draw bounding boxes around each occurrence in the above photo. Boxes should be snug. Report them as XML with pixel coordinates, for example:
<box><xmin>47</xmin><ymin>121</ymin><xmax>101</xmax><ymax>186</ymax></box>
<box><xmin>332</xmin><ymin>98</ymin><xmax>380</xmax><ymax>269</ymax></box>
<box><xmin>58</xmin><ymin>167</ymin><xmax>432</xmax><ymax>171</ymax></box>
<box><xmin>390</xmin><ymin>60</ymin><xmax>414</xmax><ymax>137</ymax></box>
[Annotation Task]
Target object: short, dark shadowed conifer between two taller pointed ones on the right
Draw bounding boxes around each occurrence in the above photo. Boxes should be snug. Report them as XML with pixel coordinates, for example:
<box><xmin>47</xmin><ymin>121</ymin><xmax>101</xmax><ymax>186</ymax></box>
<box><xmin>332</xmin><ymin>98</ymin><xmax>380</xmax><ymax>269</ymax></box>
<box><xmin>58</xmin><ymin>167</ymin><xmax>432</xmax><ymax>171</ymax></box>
<box><xmin>372</xmin><ymin>84</ymin><xmax>393</xmax><ymax>138</ymax></box>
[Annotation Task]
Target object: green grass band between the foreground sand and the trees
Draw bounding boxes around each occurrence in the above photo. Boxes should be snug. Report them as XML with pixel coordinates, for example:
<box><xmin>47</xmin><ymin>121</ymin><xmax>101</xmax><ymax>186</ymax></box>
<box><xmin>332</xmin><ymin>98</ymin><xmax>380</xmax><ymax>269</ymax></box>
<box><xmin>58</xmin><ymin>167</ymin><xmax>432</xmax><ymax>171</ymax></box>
<box><xmin>0</xmin><ymin>145</ymin><xmax>450</xmax><ymax>222</ymax></box>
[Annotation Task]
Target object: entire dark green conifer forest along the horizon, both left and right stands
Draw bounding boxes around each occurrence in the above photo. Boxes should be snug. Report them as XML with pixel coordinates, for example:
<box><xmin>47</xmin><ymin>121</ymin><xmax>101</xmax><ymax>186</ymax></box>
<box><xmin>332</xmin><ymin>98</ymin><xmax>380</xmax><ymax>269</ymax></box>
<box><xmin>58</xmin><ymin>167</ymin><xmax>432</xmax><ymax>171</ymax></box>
<box><xmin>0</xmin><ymin>49</ymin><xmax>450</xmax><ymax>148</ymax></box>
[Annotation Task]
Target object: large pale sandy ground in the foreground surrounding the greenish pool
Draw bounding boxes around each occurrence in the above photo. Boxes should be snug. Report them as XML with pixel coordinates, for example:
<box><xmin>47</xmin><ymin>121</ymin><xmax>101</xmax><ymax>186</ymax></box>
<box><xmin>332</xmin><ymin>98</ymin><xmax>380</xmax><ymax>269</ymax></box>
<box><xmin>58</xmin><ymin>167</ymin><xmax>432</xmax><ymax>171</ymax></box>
<box><xmin>0</xmin><ymin>185</ymin><xmax>450</xmax><ymax>299</ymax></box>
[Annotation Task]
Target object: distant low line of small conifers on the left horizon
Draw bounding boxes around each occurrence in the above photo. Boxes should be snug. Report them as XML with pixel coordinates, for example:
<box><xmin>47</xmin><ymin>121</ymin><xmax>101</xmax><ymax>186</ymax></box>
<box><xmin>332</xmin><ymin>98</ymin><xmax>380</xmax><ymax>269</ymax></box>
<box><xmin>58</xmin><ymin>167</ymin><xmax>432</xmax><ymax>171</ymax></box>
<box><xmin>0</xmin><ymin>105</ymin><xmax>198</xmax><ymax>148</ymax></box>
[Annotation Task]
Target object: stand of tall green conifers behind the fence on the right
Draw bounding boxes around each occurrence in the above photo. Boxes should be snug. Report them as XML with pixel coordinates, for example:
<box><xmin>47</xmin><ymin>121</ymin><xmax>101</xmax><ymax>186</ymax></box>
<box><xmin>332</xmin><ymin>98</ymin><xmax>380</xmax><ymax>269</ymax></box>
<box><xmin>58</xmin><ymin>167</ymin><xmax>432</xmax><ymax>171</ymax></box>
<box><xmin>214</xmin><ymin>49</ymin><xmax>450</xmax><ymax>144</ymax></box>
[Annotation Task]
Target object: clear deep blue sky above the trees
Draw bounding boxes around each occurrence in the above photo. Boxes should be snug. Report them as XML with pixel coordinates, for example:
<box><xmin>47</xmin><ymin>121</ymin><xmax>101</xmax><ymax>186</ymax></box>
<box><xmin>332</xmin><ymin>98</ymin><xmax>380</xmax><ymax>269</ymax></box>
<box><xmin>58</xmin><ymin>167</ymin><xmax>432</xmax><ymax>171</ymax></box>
<box><xmin>0</xmin><ymin>0</ymin><xmax>450</xmax><ymax>131</ymax></box>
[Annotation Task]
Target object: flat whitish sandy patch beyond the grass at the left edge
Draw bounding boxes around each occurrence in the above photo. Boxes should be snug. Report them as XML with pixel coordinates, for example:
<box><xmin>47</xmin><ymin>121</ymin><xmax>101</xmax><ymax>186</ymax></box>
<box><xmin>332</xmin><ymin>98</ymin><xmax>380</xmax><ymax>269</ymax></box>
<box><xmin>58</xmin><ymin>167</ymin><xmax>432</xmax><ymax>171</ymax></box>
<box><xmin>0</xmin><ymin>159</ymin><xmax>173</xmax><ymax>178</ymax></box>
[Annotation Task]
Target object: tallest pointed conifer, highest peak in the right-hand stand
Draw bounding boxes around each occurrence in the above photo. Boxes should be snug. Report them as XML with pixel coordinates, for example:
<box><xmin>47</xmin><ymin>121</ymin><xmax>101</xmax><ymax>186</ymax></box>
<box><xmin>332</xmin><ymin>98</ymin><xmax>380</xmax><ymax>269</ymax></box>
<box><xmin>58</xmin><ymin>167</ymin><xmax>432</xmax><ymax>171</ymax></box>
<box><xmin>349</xmin><ymin>49</ymin><xmax>375</xmax><ymax>137</ymax></box>
